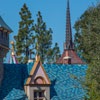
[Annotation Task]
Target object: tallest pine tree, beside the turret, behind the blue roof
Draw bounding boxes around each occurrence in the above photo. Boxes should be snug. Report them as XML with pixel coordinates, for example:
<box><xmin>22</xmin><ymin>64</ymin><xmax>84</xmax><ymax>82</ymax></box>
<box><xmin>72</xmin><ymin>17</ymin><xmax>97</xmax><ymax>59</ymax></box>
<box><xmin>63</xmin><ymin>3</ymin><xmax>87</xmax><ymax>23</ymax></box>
<box><xmin>14</xmin><ymin>4</ymin><xmax>34</xmax><ymax>63</ymax></box>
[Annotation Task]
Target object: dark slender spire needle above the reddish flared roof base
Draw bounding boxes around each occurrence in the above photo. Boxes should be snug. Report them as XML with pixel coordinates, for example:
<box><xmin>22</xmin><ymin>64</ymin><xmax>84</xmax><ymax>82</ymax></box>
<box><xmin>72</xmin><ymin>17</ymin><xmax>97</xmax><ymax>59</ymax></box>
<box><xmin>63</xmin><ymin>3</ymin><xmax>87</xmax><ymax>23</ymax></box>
<box><xmin>64</xmin><ymin>0</ymin><xmax>74</xmax><ymax>49</ymax></box>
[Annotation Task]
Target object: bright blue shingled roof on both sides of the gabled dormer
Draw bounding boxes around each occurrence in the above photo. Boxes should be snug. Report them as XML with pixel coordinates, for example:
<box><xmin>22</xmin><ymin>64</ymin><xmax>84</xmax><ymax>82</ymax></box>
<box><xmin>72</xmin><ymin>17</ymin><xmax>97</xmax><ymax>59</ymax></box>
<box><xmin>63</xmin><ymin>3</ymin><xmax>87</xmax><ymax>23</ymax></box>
<box><xmin>0</xmin><ymin>64</ymin><xmax>88</xmax><ymax>100</ymax></box>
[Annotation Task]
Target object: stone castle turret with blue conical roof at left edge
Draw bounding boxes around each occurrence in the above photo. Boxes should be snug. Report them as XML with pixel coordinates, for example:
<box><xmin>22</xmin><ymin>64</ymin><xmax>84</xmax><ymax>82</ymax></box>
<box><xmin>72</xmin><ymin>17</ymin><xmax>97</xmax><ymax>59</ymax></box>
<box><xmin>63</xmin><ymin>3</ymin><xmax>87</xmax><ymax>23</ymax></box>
<box><xmin>0</xmin><ymin>16</ymin><xmax>12</xmax><ymax>84</ymax></box>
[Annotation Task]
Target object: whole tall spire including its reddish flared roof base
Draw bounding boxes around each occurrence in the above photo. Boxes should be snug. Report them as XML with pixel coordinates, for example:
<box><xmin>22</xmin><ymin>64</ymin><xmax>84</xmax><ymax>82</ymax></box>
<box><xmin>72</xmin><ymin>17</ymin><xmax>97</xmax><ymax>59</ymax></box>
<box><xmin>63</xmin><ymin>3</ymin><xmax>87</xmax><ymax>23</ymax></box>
<box><xmin>56</xmin><ymin>0</ymin><xmax>86</xmax><ymax>65</ymax></box>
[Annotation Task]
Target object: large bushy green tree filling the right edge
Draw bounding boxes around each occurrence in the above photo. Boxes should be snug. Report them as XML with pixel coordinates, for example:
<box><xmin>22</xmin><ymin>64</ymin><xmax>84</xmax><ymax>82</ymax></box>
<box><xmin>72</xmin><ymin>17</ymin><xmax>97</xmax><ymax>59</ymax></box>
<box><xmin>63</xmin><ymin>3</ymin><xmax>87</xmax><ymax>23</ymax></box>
<box><xmin>74</xmin><ymin>4</ymin><xmax>100</xmax><ymax>100</ymax></box>
